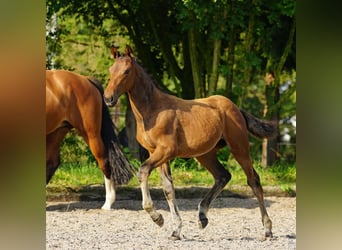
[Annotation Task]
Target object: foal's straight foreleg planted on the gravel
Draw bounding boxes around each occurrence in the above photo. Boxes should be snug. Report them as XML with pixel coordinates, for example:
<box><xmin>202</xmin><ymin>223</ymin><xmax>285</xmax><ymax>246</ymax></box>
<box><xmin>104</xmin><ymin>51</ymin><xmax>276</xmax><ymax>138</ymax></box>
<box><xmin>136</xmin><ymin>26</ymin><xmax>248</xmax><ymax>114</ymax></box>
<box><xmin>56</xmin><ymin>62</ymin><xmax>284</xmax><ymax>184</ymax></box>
<box><xmin>157</xmin><ymin>163</ymin><xmax>182</xmax><ymax>240</ymax></box>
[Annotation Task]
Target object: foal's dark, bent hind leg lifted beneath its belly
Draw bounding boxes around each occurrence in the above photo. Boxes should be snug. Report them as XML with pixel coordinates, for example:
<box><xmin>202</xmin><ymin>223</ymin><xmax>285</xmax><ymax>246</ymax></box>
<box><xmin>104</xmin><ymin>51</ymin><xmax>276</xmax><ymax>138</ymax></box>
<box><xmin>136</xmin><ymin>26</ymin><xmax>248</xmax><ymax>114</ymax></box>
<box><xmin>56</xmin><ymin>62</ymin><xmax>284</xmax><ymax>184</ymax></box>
<box><xmin>196</xmin><ymin>149</ymin><xmax>231</xmax><ymax>228</ymax></box>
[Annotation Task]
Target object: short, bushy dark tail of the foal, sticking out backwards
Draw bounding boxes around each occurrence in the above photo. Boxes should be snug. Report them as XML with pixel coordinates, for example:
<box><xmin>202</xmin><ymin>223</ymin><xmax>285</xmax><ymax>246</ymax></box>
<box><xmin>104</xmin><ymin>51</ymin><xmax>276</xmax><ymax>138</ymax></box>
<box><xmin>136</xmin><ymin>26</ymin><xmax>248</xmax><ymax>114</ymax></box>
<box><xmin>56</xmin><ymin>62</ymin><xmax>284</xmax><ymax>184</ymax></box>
<box><xmin>240</xmin><ymin>109</ymin><xmax>277</xmax><ymax>139</ymax></box>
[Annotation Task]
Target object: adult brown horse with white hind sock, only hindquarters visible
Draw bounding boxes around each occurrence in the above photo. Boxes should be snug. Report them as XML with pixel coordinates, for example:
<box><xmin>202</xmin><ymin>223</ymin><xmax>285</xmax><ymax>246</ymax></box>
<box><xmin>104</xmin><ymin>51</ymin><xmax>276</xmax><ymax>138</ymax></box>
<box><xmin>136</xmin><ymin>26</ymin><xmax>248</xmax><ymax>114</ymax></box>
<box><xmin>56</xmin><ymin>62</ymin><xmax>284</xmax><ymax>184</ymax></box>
<box><xmin>46</xmin><ymin>70</ymin><xmax>133</xmax><ymax>210</ymax></box>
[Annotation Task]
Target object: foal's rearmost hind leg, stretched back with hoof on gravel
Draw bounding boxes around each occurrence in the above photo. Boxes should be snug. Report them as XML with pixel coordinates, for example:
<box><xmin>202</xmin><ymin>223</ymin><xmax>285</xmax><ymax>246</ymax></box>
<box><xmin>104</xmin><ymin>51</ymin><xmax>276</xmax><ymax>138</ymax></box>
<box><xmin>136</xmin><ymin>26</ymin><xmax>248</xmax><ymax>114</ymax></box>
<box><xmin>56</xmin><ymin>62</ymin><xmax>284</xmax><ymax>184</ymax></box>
<box><xmin>231</xmin><ymin>146</ymin><xmax>273</xmax><ymax>237</ymax></box>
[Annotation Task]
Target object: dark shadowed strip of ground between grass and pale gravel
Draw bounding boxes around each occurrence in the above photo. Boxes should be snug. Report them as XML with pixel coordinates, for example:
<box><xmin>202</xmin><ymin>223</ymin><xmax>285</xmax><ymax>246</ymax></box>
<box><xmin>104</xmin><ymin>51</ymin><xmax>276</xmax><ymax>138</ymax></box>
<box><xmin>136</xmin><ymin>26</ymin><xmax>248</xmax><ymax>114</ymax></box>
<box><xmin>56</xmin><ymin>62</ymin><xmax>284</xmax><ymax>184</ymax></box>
<box><xmin>46</xmin><ymin>185</ymin><xmax>296</xmax><ymax>212</ymax></box>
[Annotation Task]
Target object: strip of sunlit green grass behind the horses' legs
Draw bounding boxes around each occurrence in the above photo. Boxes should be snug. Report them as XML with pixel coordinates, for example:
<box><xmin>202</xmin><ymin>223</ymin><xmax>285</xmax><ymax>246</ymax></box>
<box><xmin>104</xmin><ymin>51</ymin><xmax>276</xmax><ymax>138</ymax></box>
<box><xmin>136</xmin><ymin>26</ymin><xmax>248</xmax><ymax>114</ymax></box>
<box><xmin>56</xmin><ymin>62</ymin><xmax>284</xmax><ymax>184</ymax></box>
<box><xmin>49</xmin><ymin>159</ymin><xmax>296</xmax><ymax>191</ymax></box>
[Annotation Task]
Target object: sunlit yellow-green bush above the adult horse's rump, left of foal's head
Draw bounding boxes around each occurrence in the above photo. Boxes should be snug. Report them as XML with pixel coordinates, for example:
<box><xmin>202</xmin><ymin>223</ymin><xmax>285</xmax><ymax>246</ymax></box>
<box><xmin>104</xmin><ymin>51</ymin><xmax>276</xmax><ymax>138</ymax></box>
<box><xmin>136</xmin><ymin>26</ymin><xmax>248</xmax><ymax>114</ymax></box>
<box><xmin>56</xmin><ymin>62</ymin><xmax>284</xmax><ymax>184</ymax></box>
<box><xmin>46</xmin><ymin>8</ymin><xmax>129</xmax><ymax>84</ymax></box>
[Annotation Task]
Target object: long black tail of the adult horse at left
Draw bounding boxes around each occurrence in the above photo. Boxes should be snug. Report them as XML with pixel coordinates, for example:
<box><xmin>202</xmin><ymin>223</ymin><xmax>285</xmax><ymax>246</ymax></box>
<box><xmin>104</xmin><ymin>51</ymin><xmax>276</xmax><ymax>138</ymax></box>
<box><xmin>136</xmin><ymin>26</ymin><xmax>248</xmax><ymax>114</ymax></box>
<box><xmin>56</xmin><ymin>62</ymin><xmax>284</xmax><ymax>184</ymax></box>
<box><xmin>88</xmin><ymin>78</ymin><xmax>135</xmax><ymax>185</ymax></box>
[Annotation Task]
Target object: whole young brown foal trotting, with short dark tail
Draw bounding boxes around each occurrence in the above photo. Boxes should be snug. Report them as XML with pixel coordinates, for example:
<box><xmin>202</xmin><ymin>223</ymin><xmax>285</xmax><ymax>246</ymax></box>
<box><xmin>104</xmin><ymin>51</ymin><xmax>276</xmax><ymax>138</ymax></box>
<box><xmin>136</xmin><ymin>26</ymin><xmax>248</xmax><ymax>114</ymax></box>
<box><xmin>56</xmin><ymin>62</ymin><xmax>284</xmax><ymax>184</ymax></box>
<box><xmin>104</xmin><ymin>46</ymin><xmax>275</xmax><ymax>239</ymax></box>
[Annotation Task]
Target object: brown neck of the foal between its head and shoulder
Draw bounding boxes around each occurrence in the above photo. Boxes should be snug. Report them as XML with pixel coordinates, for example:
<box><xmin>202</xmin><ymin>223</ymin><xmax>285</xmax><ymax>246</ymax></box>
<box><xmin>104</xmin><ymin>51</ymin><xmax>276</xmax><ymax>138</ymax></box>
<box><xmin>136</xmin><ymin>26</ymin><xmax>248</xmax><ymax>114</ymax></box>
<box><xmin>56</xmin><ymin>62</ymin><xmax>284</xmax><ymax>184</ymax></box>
<box><xmin>128</xmin><ymin>63</ymin><xmax>162</xmax><ymax>118</ymax></box>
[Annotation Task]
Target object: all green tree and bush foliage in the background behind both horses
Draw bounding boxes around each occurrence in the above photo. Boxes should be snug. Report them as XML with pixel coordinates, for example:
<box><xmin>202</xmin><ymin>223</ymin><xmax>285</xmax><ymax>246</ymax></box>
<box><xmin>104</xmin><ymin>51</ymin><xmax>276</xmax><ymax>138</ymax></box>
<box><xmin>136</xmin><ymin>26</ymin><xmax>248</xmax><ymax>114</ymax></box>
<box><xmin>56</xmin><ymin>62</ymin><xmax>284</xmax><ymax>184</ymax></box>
<box><xmin>46</xmin><ymin>0</ymin><xmax>296</xmax><ymax>169</ymax></box>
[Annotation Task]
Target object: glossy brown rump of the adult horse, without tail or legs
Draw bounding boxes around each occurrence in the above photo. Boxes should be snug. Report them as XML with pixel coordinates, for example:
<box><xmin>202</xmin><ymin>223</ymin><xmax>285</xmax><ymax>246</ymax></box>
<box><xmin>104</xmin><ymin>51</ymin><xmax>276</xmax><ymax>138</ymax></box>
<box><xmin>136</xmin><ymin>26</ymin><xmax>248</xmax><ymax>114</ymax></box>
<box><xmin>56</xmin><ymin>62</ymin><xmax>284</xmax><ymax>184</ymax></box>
<box><xmin>46</xmin><ymin>70</ymin><xmax>102</xmax><ymax>132</ymax></box>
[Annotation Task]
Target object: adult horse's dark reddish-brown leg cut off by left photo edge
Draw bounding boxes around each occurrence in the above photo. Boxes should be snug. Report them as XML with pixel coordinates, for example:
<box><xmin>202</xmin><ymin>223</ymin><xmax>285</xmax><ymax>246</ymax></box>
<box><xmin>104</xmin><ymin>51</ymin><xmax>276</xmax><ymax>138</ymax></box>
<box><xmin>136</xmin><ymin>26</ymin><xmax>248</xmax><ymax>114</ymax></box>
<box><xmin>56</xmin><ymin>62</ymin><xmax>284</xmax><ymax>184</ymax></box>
<box><xmin>46</xmin><ymin>127</ymin><xmax>69</xmax><ymax>185</ymax></box>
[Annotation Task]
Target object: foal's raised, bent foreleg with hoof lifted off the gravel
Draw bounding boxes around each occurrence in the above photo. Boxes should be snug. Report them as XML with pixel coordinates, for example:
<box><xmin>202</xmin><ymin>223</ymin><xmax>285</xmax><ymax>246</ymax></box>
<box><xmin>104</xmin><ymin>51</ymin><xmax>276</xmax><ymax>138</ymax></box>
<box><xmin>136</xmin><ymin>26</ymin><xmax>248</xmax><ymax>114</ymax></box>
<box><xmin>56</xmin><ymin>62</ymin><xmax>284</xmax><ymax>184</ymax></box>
<box><xmin>138</xmin><ymin>162</ymin><xmax>164</xmax><ymax>227</ymax></box>
